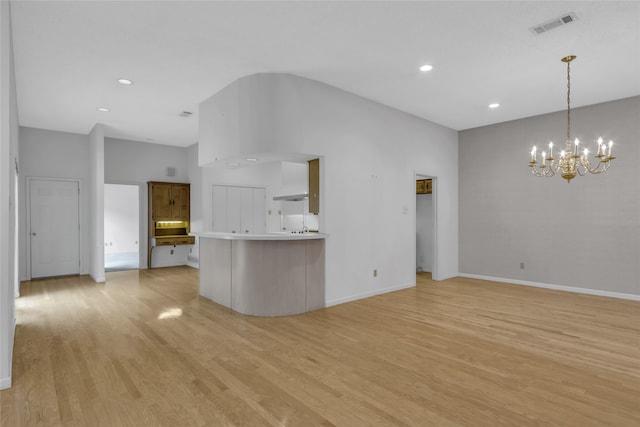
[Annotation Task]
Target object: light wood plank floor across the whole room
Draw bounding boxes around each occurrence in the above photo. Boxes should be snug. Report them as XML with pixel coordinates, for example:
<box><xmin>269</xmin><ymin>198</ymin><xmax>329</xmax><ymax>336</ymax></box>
<box><xmin>0</xmin><ymin>267</ymin><xmax>640</xmax><ymax>427</ymax></box>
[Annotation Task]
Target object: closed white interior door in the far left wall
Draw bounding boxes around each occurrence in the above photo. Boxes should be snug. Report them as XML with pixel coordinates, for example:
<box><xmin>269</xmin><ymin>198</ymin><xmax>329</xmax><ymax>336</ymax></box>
<box><xmin>29</xmin><ymin>179</ymin><xmax>80</xmax><ymax>278</ymax></box>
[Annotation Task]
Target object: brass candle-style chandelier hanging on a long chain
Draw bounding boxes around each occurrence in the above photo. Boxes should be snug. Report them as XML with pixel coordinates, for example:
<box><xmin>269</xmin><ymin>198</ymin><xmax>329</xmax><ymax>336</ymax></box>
<box><xmin>529</xmin><ymin>55</ymin><xmax>615</xmax><ymax>183</ymax></box>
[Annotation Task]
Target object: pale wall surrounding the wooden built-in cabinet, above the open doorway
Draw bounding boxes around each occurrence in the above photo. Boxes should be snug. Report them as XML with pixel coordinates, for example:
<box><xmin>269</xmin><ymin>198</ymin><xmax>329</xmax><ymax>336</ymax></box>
<box><xmin>104</xmin><ymin>138</ymin><xmax>194</xmax><ymax>267</ymax></box>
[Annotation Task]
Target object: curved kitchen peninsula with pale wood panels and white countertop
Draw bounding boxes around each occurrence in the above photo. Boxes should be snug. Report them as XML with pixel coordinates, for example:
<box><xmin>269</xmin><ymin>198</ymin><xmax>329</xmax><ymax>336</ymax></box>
<box><xmin>194</xmin><ymin>232</ymin><xmax>327</xmax><ymax>316</ymax></box>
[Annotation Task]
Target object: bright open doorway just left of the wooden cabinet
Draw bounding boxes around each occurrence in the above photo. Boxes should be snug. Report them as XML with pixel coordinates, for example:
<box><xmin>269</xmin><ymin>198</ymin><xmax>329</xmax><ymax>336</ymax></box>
<box><xmin>104</xmin><ymin>184</ymin><xmax>140</xmax><ymax>271</ymax></box>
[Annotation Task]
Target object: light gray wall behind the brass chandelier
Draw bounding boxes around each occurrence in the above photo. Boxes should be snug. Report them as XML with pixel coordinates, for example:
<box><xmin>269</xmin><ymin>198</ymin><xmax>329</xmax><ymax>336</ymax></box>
<box><xmin>460</xmin><ymin>97</ymin><xmax>640</xmax><ymax>296</ymax></box>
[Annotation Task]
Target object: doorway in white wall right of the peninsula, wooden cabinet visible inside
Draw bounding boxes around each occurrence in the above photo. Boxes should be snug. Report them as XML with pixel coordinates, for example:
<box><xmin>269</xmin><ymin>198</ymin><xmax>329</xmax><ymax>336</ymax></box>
<box><xmin>415</xmin><ymin>173</ymin><xmax>438</xmax><ymax>280</ymax></box>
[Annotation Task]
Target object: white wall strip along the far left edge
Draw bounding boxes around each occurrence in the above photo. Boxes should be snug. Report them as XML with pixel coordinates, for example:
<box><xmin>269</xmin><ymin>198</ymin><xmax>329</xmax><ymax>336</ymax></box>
<box><xmin>0</xmin><ymin>1</ymin><xmax>20</xmax><ymax>390</ymax></box>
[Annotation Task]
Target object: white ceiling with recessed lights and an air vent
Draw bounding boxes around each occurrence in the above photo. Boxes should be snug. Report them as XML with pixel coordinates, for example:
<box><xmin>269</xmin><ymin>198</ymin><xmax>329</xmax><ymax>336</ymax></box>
<box><xmin>10</xmin><ymin>0</ymin><xmax>640</xmax><ymax>146</ymax></box>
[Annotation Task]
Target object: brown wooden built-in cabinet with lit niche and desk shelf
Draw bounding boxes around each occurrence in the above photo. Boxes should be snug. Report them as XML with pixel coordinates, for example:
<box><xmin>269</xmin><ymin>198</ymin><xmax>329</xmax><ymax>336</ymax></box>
<box><xmin>147</xmin><ymin>181</ymin><xmax>195</xmax><ymax>268</ymax></box>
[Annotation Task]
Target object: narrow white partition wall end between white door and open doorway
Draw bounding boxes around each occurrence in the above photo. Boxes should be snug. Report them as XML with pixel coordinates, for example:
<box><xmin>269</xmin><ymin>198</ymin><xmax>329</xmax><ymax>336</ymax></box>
<box><xmin>89</xmin><ymin>123</ymin><xmax>106</xmax><ymax>282</ymax></box>
